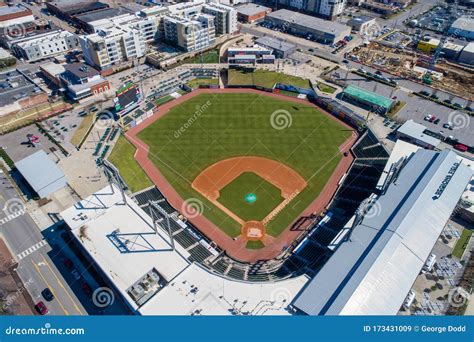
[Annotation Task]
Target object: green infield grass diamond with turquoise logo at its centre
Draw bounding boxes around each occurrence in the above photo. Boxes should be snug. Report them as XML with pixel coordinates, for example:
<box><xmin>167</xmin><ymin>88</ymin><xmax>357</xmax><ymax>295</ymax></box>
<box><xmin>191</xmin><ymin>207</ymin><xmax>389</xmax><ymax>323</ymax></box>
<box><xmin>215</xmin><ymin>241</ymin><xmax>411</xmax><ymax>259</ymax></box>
<box><xmin>217</xmin><ymin>172</ymin><xmax>284</xmax><ymax>221</ymax></box>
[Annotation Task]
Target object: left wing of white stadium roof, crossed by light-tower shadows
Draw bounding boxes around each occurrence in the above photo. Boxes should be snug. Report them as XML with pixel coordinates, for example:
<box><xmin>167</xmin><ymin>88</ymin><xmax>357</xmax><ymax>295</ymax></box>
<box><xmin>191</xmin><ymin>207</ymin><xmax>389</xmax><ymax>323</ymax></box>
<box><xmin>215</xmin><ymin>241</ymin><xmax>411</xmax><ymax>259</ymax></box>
<box><xmin>61</xmin><ymin>186</ymin><xmax>189</xmax><ymax>309</ymax></box>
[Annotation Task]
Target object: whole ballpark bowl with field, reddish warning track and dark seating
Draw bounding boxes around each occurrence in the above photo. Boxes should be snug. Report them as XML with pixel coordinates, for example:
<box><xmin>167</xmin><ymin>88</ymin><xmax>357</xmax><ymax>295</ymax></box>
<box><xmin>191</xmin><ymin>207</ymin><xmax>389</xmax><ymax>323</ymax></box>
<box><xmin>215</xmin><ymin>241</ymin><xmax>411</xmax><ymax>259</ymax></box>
<box><xmin>105</xmin><ymin>88</ymin><xmax>388</xmax><ymax>281</ymax></box>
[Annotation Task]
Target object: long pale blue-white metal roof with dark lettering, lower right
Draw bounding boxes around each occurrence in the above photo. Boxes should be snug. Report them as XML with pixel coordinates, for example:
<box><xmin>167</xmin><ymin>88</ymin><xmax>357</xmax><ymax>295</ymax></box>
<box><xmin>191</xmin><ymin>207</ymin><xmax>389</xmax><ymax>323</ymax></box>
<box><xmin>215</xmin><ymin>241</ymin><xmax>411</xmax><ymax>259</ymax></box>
<box><xmin>293</xmin><ymin>150</ymin><xmax>473</xmax><ymax>315</ymax></box>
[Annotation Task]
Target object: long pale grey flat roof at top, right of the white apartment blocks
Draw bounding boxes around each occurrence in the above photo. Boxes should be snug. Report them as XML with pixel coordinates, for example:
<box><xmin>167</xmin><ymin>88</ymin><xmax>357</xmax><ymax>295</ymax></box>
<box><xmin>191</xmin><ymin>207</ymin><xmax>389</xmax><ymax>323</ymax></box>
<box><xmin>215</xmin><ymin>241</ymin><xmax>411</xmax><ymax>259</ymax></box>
<box><xmin>267</xmin><ymin>9</ymin><xmax>351</xmax><ymax>37</ymax></box>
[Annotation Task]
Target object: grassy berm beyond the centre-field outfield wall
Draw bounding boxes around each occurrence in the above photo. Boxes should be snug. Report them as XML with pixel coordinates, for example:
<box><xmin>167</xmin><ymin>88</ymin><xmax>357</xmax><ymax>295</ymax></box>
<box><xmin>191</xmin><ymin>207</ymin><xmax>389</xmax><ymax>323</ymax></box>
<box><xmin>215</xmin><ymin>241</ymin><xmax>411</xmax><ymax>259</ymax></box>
<box><xmin>228</xmin><ymin>69</ymin><xmax>311</xmax><ymax>89</ymax></box>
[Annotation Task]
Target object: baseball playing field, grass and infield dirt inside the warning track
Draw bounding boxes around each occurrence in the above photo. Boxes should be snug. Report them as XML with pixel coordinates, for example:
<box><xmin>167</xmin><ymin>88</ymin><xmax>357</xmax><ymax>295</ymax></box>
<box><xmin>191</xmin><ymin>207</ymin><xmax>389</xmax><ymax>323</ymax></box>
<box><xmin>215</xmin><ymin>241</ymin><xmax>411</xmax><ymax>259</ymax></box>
<box><xmin>137</xmin><ymin>92</ymin><xmax>352</xmax><ymax>240</ymax></box>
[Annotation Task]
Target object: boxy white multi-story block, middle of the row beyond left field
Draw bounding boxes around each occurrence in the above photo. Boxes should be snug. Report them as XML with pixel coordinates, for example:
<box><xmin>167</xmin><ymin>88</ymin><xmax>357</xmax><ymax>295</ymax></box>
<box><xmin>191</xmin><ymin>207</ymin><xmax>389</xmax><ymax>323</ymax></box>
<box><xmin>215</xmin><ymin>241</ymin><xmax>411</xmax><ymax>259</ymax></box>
<box><xmin>163</xmin><ymin>14</ymin><xmax>216</xmax><ymax>52</ymax></box>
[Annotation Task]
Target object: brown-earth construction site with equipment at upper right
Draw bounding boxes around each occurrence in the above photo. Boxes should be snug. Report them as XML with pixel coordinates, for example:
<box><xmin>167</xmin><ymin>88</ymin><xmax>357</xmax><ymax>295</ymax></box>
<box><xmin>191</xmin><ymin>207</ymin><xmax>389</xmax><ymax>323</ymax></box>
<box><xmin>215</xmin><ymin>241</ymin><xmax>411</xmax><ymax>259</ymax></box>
<box><xmin>348</xmin><ymin>41</ymin><xmax>474</xmax><ymax>101</ymax></box>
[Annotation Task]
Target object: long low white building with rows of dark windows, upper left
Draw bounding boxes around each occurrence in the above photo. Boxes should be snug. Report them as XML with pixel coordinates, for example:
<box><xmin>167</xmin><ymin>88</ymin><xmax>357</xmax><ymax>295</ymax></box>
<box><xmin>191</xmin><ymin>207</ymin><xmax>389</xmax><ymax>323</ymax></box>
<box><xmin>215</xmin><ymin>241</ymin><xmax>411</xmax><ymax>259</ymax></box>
<box><xmin>11</xmin><ymin>30</ymin><xmax>79</xmax><ymax>62</ymax></box>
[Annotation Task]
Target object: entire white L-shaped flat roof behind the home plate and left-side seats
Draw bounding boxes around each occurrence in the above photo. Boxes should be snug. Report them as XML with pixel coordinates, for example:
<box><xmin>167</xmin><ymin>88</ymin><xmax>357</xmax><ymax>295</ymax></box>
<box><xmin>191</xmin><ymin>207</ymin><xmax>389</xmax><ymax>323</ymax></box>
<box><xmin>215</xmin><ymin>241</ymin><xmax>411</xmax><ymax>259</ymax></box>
<box><xmin>60</xmin><ymin>185</ymin><xmax>309</xmax><ymax>315</ymax></box>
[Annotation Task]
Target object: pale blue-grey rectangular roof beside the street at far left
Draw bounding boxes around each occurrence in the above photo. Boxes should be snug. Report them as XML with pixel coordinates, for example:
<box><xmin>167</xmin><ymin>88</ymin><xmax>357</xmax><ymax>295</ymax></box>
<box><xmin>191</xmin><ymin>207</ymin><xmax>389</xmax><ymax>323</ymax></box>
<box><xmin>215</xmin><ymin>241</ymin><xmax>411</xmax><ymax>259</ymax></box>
<box><xmin>15</xmin><ymin>150</ymin><xmax>67</xmax><ymax>198</ymax></box>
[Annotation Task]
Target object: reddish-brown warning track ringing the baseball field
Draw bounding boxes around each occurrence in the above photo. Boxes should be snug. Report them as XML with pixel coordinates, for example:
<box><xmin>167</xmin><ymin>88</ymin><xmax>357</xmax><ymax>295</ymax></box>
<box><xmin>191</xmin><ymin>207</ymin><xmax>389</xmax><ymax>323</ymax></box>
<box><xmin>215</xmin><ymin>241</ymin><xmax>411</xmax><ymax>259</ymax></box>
<box><xmin>125</xmin><ymin>88</ymin><xmax>357</xmax><ymax>262</ymax></box>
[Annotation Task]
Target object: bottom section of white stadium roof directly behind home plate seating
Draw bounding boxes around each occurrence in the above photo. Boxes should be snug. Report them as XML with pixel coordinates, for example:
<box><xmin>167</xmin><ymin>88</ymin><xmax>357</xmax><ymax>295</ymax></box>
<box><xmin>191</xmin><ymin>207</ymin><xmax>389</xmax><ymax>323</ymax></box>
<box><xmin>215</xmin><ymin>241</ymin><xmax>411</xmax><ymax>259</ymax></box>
<box><xmin>140</xmin><ymin>264</ymin><xmax>308</xmax><ymax>316</ymax></box>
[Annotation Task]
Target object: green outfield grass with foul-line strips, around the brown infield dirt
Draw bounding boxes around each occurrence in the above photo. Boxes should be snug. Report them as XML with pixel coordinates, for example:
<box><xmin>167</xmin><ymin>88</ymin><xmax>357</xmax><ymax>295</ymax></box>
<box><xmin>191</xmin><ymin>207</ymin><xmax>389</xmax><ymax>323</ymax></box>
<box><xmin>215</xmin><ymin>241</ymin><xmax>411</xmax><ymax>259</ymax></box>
<box><xmin>135</xmin><ymin>93</ymin><xmax>351</xmax><ymax>237</ymax></box>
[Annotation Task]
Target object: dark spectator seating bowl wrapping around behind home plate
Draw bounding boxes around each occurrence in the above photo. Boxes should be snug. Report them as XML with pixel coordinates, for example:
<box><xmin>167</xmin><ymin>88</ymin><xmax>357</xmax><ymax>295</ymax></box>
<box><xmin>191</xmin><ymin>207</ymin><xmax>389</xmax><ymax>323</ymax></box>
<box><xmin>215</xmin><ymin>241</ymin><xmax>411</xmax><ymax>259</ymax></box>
<box><xmin>127</xmin><ymin>130</ymin><xmax>388</xmax><ymax>282</ymax></box>
